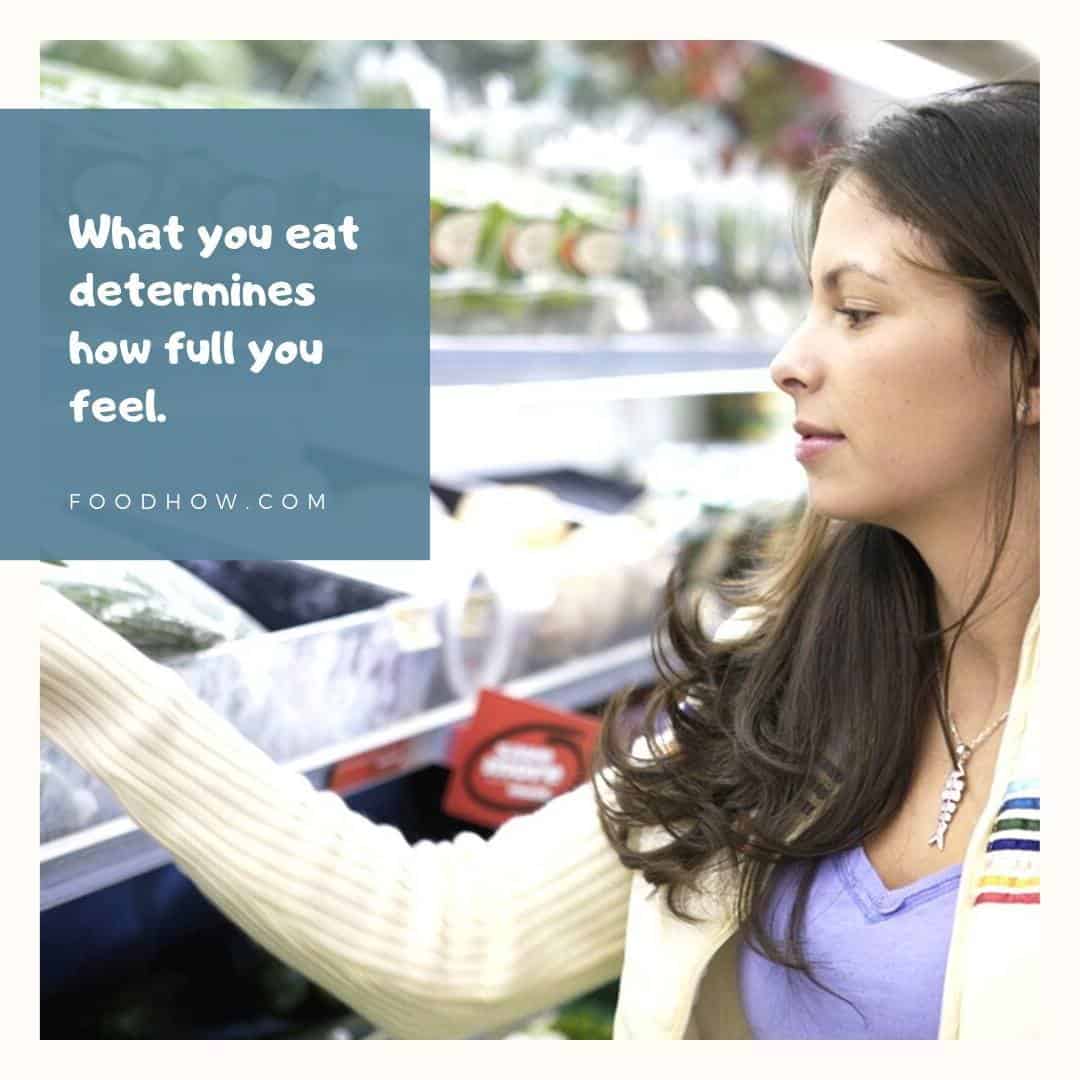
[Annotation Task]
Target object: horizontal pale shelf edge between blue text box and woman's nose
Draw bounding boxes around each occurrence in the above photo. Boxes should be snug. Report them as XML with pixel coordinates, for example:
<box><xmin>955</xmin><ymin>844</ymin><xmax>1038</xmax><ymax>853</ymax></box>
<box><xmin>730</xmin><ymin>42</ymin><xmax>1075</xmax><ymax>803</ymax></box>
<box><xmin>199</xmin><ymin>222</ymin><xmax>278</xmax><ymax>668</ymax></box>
<box><xmin>431</xmin><ymin>334</ymin><xmax>783</xmax><ymax>402</ymax></box>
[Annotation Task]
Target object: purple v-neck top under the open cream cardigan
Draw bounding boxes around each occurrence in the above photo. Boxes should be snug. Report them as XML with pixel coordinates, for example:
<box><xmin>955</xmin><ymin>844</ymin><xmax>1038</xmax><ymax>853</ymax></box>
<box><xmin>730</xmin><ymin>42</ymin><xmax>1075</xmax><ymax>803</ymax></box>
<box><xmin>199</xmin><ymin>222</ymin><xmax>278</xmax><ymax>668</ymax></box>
<box><xmin>739</xmin><ymin>845</ymin><xmax>960</xmax><ymax>1039</ymax></box>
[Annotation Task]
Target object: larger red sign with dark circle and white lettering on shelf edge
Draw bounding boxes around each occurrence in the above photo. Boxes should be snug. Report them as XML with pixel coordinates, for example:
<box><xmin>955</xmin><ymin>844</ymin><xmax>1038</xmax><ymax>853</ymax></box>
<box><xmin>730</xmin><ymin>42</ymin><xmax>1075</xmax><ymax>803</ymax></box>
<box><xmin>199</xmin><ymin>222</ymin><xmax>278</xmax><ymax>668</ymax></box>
<box><xmin>443</xmin><ymin>690</ymin><xmax>599</xmax><ymax>828</ymax></box>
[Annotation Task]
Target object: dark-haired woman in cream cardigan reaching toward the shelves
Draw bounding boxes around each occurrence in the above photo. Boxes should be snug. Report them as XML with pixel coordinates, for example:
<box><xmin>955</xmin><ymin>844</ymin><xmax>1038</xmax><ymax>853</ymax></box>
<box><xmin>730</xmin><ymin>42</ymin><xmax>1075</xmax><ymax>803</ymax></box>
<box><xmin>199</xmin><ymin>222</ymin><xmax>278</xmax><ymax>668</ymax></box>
<box><xmin>41</xmin><ymin>76</ymin><xmax>1039</xmax><ymax>1039</ymax></box>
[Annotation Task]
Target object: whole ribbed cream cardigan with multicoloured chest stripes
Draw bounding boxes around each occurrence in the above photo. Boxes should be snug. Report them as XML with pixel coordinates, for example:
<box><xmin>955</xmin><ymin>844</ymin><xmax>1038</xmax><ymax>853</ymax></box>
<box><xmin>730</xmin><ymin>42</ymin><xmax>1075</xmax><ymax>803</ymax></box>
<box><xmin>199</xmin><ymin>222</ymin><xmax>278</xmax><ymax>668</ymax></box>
<box><xmin>40</xmin><ymin>586</ymin><xmax>1039</xmax><ymax>1039</ymax></box>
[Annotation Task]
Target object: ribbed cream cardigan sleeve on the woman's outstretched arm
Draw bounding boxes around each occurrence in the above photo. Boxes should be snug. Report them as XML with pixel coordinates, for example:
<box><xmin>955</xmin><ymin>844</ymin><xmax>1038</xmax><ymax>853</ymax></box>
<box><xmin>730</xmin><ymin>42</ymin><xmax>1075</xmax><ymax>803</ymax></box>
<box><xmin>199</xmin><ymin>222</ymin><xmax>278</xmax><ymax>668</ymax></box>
<box><xmin>40</xmin><ymin>586</ymin><xmax>631</xmax><ymax>1038</ymax></box>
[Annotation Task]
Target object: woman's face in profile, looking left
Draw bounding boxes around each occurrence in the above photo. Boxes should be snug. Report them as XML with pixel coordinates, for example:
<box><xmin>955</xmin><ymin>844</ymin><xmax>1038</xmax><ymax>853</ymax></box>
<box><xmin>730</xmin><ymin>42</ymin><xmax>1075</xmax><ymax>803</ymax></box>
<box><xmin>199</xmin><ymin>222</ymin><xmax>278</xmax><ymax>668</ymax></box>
<box><xmin>770</xmin><ymin>178</ymin><xmax>1014</xmax><ymax>531</ymax></box>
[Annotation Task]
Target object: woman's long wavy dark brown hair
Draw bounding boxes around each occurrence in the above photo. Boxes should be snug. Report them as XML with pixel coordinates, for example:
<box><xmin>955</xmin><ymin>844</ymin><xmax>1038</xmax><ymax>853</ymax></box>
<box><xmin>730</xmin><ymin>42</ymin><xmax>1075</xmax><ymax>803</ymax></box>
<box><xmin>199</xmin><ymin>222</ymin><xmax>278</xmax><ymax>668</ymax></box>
<box><xmin>594</xmin><ymin>81</ymin><xmax>1039</xmax><ymax>1006</ymax></box>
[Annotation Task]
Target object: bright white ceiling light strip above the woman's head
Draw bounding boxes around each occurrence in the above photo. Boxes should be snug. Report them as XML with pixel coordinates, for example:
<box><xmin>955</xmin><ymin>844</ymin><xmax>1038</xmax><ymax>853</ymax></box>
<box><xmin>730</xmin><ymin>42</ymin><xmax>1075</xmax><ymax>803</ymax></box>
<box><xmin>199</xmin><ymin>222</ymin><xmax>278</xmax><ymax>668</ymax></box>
<box><xmin>761</xmin><ymin>38</ymin><xmax>971</xmax><ymax>98</ymax></box>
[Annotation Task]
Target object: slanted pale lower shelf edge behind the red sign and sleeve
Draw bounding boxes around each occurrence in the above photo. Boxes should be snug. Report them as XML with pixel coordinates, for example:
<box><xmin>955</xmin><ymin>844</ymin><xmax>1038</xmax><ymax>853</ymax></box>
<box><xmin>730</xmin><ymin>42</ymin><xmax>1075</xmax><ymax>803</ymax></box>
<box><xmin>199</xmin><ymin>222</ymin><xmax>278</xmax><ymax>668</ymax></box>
<box><xmin>40</xmin><ymin>637</ymin><xmax>656</xmax><ymax>912</ymax></box>
